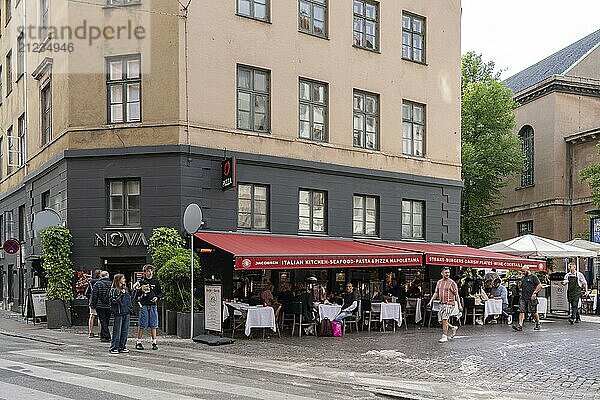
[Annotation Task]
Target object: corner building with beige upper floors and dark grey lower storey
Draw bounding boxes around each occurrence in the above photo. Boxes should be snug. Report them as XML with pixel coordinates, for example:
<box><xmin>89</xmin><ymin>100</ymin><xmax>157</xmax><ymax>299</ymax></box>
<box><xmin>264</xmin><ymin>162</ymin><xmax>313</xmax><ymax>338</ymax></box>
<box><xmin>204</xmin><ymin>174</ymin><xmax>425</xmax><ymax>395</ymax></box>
<box><xmin>0</xmin><ymin>0</ymin><xmax>462</xmax><ymax>306</ymax></box>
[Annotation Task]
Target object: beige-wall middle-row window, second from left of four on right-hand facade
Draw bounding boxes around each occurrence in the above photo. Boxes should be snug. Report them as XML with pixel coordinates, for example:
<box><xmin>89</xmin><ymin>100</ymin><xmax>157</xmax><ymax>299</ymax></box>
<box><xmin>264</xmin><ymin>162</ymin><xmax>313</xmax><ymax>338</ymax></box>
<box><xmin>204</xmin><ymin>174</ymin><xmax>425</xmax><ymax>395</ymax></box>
<box><xmin>299</xmin><ymin>79</ymin><xmax>327</xmax><ymax>142</ymax></box>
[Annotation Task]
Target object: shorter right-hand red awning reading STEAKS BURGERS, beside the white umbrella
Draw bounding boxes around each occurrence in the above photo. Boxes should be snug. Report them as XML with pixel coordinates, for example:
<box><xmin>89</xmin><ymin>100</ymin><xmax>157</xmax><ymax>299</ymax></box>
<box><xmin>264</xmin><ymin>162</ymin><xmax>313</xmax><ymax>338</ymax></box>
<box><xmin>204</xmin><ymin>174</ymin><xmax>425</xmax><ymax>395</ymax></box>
<box><xmin>364</xmin><ymin>240</ymin><xmax>546</xmax><ymax>271</ymax></box>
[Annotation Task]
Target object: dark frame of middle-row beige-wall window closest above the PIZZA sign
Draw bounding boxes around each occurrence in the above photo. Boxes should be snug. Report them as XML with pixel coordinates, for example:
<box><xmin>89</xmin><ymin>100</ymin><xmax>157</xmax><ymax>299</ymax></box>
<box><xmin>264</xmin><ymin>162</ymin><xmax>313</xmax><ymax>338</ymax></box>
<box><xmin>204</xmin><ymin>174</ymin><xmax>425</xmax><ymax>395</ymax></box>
<box><xmin>235</xmin><ymin>64</ymin><xmax>271</xmax><ymax>134</ymax></box>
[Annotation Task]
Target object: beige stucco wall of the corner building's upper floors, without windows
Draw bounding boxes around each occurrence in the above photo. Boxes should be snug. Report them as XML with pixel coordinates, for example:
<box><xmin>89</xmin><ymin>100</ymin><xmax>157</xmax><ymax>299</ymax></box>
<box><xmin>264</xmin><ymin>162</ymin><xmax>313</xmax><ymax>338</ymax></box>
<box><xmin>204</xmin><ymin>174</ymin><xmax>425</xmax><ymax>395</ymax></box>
<box><xmin>0</xmin><ymin>0</ymin><xmax>460</xmax><ymax>197</ymax></box>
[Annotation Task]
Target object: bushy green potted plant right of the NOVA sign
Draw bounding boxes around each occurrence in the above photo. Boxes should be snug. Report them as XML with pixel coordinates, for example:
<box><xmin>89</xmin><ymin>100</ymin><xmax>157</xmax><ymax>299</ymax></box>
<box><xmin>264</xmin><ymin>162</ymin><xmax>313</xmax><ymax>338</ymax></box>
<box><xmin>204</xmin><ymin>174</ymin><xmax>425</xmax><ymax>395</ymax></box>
<box><xmin>157</xmin><ymin>253</ymin><xmax>204</xmax><ymax>338</ymax></box>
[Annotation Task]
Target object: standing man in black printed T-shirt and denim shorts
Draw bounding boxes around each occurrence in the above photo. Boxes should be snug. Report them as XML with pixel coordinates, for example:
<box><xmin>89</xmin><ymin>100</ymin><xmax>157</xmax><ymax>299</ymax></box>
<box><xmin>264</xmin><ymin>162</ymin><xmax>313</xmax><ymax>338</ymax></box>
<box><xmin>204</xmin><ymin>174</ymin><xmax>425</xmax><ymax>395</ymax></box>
<box><xmin>133</xmin><ymin>264</ymin><xmax>162</xmax><ymax>350</ymax></box>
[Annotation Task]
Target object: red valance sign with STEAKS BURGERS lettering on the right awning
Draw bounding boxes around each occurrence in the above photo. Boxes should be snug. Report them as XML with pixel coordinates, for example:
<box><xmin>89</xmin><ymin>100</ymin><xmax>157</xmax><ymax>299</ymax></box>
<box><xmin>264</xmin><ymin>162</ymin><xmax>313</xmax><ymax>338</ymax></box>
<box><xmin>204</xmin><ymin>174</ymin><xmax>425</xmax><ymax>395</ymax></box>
<box><xmin>425</xmin><ymin>254</ymin><xmax>546</xmax><ymax>271</ymax></box>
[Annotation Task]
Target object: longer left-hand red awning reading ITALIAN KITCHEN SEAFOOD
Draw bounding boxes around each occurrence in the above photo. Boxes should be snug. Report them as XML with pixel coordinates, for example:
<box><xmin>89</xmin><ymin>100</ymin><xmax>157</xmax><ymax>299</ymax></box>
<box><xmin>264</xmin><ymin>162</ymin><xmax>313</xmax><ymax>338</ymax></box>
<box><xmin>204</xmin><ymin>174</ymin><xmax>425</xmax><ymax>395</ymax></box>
<box><xmin>196</xmin><ymin>232</ymin><xmax>423</xmax><ymax>270</ymax></box>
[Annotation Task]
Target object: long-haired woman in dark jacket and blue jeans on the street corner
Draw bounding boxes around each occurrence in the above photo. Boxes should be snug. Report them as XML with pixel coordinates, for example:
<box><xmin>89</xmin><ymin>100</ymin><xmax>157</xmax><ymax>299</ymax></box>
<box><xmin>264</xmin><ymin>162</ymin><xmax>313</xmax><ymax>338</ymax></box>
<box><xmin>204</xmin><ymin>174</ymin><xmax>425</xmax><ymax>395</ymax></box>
<box><xmin>109</xmin><ymin>274</ymin><xmax>133</xmax><ymax>354</ymax></box>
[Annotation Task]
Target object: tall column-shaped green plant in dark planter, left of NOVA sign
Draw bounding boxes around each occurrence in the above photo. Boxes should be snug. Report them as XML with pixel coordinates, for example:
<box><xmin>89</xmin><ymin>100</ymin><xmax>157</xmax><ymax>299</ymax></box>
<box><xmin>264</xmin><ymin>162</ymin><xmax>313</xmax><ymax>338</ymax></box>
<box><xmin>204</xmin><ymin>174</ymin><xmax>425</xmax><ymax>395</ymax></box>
<box><xmin>40</xmin><ymin>226</ymin><xmax>75</xmax><ymax>329</ymax></box>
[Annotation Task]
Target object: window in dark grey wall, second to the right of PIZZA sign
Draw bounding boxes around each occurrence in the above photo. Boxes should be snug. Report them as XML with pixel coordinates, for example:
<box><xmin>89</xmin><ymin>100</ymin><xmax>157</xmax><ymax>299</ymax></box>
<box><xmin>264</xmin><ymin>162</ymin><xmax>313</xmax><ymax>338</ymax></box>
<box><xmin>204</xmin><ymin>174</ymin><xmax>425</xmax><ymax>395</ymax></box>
<box><xmin>298</xmin><ymin>189</ymin><xmax>327</xmax><ymax>233</ymax></box>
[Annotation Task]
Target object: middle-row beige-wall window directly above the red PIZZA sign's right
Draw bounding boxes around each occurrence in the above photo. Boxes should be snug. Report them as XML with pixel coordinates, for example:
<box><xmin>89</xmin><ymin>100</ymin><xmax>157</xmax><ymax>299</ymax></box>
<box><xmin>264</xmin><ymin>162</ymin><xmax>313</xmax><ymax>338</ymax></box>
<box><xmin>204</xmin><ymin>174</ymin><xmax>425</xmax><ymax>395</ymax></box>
<box><xmin>237</xmin><ymin>66</ymin><xmax>271</xmax><ymax>132</ymax></box>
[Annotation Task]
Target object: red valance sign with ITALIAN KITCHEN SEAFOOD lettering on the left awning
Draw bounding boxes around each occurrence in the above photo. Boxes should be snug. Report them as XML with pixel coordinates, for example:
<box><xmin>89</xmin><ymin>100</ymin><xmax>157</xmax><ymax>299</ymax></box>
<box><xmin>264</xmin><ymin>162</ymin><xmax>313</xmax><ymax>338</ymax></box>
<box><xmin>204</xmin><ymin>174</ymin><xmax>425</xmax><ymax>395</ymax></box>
<box><xmin>235</xmin><ymin>254</ymin><xmax>423</xmax><ymax>270</ymax></box>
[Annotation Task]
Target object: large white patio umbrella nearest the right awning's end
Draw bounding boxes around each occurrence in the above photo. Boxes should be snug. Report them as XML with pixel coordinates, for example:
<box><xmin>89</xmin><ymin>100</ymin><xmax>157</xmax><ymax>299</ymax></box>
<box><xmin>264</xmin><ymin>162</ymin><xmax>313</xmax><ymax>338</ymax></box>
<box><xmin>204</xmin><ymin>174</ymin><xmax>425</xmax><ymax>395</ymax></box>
<box><xmin>482</xmin><ymin>235</ymin><xmax>597</xmax><ymax>258</ymax></box>
